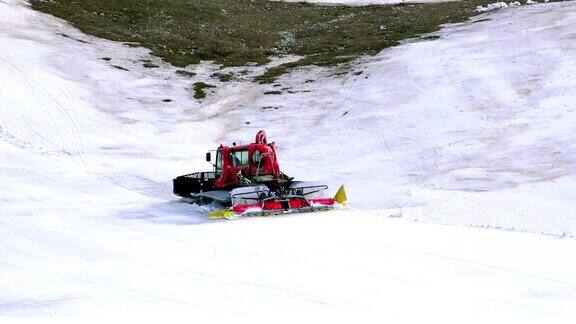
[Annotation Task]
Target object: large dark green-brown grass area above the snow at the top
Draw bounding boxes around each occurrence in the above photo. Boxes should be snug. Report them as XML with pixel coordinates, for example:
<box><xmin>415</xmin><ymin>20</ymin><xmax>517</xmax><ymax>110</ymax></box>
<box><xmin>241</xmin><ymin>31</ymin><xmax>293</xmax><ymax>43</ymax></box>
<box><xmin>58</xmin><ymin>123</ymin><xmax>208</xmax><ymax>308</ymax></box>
<box><xmin>31</xmin><ymin>0</ymin><xmax>493</xmax><ymax>83</ymax></box>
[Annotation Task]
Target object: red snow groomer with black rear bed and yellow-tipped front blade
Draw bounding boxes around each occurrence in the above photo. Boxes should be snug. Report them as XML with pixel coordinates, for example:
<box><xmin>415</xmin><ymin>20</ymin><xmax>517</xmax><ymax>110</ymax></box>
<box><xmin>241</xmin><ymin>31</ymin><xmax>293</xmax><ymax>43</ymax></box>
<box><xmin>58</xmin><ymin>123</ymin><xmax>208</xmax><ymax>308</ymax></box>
<box><xmin>173</xmin><ymin>130</ymin><xmax>346</xmax><ymax>219</ymax></box>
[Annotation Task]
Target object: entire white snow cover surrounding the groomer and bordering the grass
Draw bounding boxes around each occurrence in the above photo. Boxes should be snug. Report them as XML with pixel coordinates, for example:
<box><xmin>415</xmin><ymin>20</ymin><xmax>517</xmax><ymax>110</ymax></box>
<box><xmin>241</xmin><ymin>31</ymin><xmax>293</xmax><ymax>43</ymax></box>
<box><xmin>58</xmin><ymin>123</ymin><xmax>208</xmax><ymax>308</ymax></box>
<box><xmin>0</xmin><ymin>0</ymin><xmax>576</xmax><ymax>323</ymax></box>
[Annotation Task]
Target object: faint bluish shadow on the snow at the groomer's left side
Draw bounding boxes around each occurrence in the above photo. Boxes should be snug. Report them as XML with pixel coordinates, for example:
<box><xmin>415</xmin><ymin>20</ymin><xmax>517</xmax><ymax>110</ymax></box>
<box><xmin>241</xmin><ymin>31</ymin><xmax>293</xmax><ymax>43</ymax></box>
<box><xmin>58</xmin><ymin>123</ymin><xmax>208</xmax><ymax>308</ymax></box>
<box><xmin>117</xmin><ymin>200</ymin><xmax>215</xmax><ymax>225</ymax></box>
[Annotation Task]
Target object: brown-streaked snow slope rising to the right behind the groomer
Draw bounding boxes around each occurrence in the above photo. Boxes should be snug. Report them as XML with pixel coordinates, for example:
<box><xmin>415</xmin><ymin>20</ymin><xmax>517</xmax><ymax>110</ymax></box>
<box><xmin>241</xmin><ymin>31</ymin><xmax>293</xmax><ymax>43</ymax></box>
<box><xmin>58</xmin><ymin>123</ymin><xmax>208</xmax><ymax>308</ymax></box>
<box><xmin>236</xmin><ymin>3</ymin><xmax>576</xmax><ymax>235</ymax></box>
